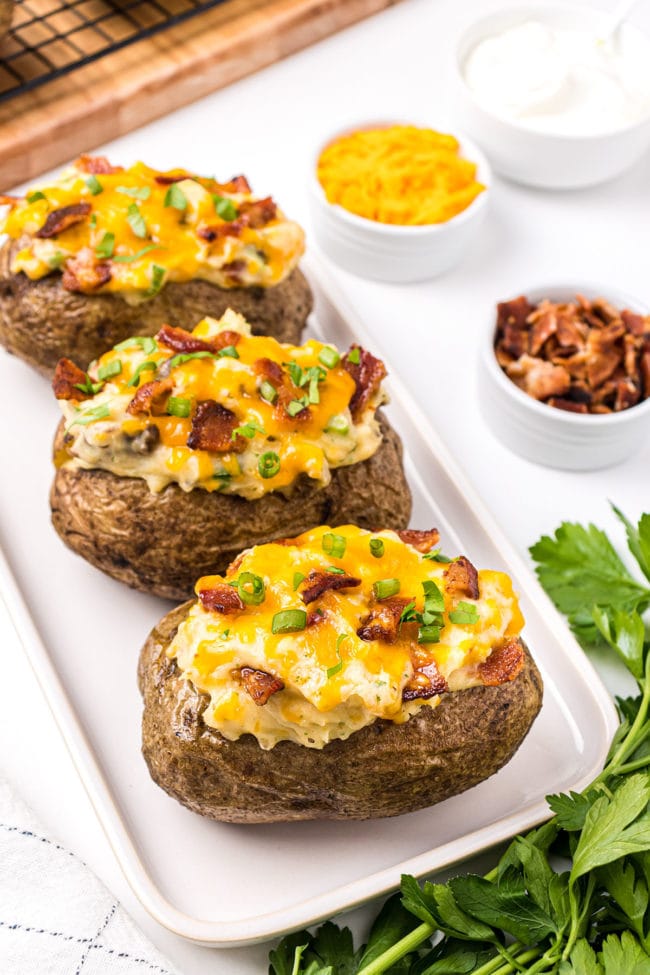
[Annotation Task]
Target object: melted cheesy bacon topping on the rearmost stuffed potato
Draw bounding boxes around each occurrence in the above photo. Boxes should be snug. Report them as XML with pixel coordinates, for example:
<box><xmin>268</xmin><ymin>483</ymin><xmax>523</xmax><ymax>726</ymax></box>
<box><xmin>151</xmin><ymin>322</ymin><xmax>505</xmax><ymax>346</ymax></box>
<box><xmin>0</xmin><ymin>157</ymin><xmax>304</xmax><ymax>302</ymax></box>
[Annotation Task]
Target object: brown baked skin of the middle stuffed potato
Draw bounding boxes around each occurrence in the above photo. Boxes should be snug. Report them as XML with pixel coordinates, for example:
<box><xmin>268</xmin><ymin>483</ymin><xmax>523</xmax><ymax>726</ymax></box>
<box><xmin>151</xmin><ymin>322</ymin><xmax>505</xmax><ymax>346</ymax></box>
<box><xmin>50</xmin><ymin>414</ymin><xmax>411</xmax><ymax>602</ymax></box>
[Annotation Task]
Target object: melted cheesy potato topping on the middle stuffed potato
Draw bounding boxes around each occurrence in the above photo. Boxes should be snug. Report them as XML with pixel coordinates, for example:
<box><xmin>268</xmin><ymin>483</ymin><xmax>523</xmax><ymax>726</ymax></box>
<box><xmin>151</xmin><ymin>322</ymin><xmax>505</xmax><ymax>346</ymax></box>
<box><xmin>54</xmin><ymin>310</ymin><xmax>385</xmax><ymax>500</ymax></box>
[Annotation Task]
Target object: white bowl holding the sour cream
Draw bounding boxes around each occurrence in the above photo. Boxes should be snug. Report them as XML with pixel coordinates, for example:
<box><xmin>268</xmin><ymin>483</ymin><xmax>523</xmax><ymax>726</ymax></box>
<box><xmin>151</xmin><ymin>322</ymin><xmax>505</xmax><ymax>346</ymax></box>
<box><xmin>451</xmin><ymin>3</ymin><xmax>650</xmax><ymax>189</ymax></box>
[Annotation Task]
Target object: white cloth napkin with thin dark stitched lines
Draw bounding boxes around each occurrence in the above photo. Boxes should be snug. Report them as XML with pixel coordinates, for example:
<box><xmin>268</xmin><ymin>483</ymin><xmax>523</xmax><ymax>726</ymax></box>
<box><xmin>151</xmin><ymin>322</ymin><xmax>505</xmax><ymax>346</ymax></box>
<box><xmin>0</xmin><ymin>780</ymin><xmax>177</xmax><ymax>975</ymax></box>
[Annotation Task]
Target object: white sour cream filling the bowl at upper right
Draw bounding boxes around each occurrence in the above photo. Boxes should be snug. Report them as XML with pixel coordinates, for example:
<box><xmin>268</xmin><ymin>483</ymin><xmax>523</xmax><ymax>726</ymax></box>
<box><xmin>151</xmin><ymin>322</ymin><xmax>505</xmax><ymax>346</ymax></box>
<box><xmin>463</xmin><ymin>21</ymin><xmax>650</xmax><ymax>135</ymax></box>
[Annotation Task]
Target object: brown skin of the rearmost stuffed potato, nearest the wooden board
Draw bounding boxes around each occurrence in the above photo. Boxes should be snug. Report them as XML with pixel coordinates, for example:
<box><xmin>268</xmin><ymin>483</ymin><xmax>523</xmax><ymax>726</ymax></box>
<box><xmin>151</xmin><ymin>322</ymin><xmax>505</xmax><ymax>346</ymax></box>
<box><xmin>0</xmin><ymin>238</ymin><xmax>313</xmax><ymax>376</ymax></box>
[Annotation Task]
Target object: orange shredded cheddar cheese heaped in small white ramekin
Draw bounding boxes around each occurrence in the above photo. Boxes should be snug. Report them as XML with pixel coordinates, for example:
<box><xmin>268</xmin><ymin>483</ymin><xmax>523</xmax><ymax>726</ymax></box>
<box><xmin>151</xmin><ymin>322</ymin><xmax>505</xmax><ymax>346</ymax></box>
<box><xmin>317</xmin><ymin>125</ymin><xmax>485</xmax><ymax>226</ymax></box>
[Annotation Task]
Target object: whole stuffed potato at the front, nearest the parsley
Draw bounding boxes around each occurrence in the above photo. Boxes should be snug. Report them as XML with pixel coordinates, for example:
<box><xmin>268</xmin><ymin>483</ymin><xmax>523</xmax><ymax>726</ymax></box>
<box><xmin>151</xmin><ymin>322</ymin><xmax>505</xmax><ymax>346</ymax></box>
<box><xmin>139</xmin><ymin>525</ymin><xmax>542</xmax><ymax>823</ymax></box>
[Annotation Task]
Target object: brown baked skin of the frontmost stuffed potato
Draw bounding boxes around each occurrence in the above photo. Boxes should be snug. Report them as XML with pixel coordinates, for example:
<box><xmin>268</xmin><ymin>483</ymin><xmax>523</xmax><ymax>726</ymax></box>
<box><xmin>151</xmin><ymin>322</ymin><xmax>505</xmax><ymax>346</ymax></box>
<box><xmin>138</xmin><ymin>601</ymin><xmax>542</xmax><ymax>823</ymax></box>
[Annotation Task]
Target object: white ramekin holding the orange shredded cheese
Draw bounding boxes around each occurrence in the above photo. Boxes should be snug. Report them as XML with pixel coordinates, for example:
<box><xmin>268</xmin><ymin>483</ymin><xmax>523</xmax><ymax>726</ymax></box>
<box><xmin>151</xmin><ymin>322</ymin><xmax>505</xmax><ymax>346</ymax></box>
<box><xmin>309</xmin><ymin>119</ymin><xmax>491</xmax><ymax>283</ymax></box>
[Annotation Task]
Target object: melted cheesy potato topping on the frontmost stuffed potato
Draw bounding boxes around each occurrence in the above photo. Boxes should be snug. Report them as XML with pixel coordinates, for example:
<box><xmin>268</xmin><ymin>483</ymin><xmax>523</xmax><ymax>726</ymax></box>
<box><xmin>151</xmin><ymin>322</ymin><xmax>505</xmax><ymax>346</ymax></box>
<box><xmin>168</xmin><ymin>525</ymin><xmax>524</xmax><ymax>749</ymax></box>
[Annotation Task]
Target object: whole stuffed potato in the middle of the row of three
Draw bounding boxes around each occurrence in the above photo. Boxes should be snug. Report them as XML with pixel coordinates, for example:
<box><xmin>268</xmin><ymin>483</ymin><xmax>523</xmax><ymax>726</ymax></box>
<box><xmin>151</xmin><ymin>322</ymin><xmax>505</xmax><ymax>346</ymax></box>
<box><xmin>50</xmin><ymin>312</ymin><xmax>411</xmax><ymax>600</ymax></box>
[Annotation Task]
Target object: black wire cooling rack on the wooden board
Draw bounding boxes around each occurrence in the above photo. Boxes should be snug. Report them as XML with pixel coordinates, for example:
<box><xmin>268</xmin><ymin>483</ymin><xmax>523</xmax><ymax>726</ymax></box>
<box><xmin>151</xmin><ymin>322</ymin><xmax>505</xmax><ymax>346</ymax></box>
<box><xmin>0</xmin><ymin>0</ymin><xmax>224</xmax><ymax>101</ymax></box>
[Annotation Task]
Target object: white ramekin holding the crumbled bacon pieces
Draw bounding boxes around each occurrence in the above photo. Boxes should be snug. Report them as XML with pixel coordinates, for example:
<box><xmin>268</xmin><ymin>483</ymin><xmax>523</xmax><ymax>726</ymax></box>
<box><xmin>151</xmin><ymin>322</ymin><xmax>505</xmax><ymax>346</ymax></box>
<box><xmin>478</xmin><ymin>284</ymin><xmax>650</xmax><ymax>471</ymax></box>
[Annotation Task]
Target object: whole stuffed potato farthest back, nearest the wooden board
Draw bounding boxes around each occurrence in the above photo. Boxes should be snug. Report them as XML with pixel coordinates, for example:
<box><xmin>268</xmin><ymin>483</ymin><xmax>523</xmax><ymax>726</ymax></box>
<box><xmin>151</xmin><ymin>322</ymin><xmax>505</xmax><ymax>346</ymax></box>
<box><xmin>0</xmin><ymin>156</ymin><xmax>312</xmax><ymax>375</ymax></box>
